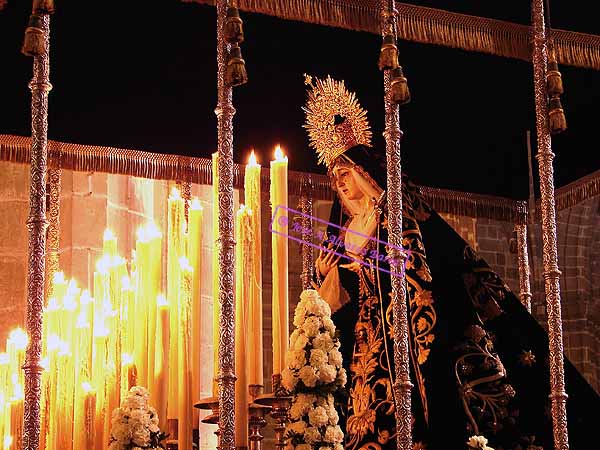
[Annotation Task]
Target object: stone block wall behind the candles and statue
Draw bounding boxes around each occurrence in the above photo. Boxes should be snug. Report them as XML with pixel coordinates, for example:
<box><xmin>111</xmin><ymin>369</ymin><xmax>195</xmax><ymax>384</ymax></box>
<box><xmin>0</xmin><ymin>162</ymin><xmax>600</xmax><ymax>414</ymax></box>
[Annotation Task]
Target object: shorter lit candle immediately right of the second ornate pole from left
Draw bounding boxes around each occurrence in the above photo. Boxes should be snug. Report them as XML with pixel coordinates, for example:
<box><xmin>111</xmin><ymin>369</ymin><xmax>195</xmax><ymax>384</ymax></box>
<box><xmin>235</xmin><ymin>205</ymin><xmax>254</xmax><ymax>448</ymax></box>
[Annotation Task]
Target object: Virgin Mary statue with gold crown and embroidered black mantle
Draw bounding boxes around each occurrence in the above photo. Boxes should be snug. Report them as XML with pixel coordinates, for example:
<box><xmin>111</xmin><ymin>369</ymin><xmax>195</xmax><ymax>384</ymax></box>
<box><xmin>303</xmin><ymin>76</ymin><xmax>600</xmax><ymax>450</ymax></box>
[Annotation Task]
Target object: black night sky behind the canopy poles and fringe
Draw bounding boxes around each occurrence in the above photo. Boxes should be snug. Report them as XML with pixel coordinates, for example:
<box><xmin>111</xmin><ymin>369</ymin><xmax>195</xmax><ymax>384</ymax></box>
<box><xmin>0</xmin><ymin>0</ymin><xmax>600</xmax><ymax>199</ymax></box>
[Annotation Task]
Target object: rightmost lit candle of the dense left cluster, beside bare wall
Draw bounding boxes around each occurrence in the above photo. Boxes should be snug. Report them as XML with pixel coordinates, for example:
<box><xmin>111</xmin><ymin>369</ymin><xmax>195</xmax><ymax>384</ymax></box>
<box><xmin>187</xmin><ymin>198</ymin><xmax>203</xmax><ymax>428</ymax></box>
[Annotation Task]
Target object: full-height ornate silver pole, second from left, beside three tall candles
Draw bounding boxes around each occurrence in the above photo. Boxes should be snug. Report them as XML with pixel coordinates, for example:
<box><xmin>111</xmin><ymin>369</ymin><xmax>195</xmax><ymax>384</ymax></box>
<box><xmin>215</xmin><ymin>0</ymin><xmax>235</xmax><ymax>450</ymax></box>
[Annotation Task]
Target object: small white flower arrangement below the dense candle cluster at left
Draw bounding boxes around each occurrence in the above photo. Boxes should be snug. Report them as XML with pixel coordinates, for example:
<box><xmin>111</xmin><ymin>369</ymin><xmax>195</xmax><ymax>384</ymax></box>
<box><xmin>108</xmin><ymin>386</ymin><xmax>167</xmax><ymax>450</ymax></box>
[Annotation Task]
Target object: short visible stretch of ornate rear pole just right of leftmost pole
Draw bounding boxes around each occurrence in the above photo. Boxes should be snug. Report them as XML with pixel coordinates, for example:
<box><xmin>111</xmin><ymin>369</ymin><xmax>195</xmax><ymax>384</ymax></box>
<box><xmin>45</xmin><ymin>167</ymin><xmax>62</xmax><ymax>297</ymax></box>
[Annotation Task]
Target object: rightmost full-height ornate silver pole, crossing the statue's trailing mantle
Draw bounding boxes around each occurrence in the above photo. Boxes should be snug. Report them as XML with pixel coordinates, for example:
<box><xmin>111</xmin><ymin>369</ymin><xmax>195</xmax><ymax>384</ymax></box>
<box><xmin>532</xmin><ymin>0</ymin><xmax>569</xmax><ymax>450</ymax></box>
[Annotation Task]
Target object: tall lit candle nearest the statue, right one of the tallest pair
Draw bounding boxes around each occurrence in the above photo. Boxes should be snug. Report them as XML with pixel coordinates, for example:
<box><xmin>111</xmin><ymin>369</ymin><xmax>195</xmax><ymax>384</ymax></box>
<box><xmin>271</xmin><ymin>146</ymin><xmax>289</xmax><ymax>374</ymax></box>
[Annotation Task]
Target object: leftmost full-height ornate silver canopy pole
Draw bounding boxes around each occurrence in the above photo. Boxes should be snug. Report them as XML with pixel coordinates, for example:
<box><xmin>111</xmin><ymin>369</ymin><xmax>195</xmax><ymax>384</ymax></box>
<box><xmin>23</xmin><ymin>13</ymin><xmax>52</xmax><ymax>450</ymax></box>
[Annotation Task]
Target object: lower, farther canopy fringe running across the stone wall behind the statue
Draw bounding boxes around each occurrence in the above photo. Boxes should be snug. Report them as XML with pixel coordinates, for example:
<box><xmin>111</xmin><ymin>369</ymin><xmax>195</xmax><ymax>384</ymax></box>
<box><xmin>0</xmin><ymin>134</ymin><xmax>600</xmax><ymax>224</ymax></box>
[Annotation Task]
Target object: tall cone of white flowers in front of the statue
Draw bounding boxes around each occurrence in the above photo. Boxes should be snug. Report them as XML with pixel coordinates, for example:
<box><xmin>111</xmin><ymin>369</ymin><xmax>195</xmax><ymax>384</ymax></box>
<box><xmin>281</xmin><ymin>289</ymin><xmax>347</xmax><ymax>450</ymax></box>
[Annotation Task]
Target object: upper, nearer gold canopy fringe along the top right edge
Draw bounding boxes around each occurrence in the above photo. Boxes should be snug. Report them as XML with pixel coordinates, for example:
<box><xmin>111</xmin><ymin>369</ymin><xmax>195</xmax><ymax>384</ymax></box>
<box><xmin>183</xmin><ymin>0</ymin><xmax>600</xmax><ymax>70</ymax></box>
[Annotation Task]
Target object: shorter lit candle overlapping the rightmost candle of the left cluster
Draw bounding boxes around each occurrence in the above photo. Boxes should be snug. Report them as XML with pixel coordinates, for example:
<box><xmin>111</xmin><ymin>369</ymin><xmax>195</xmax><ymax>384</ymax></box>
<box><xmin>177</xmin><ymin>257</ymin><xmax>194</xmax><ymax>450</ymax></box>
